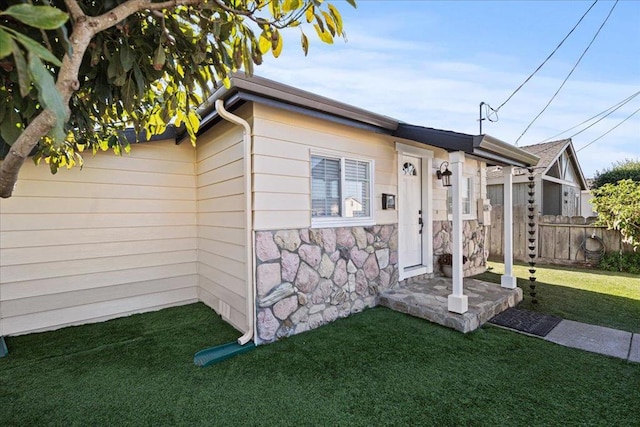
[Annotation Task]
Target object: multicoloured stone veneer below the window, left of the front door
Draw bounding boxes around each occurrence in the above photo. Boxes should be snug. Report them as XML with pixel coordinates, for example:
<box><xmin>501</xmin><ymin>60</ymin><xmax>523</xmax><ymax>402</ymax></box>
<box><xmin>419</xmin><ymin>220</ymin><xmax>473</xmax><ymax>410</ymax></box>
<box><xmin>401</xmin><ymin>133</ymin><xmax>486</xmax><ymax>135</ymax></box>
<box><xmin>255</xmin><ymin>225</ymin><xmax>398</xmax><ymax>344</ymax></box>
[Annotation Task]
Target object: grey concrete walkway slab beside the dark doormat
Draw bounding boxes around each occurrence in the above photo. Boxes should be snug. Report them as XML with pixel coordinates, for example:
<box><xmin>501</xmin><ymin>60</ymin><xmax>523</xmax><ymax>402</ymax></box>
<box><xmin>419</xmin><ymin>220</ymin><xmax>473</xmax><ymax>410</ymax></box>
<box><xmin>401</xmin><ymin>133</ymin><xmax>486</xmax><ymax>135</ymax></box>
<box><xmin>543</xmin><ymin>320</ymin><xmax>640</xmax><ymax>363</ymax></box>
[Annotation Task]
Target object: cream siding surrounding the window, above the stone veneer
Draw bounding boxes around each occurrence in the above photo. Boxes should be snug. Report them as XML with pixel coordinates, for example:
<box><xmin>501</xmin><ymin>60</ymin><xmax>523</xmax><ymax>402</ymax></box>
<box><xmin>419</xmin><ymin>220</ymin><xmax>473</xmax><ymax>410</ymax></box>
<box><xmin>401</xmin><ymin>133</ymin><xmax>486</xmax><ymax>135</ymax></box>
<box><xmin>253</xmin><ymin>104</ymin><xmax>398</xmax><ymax>230</ymax></box>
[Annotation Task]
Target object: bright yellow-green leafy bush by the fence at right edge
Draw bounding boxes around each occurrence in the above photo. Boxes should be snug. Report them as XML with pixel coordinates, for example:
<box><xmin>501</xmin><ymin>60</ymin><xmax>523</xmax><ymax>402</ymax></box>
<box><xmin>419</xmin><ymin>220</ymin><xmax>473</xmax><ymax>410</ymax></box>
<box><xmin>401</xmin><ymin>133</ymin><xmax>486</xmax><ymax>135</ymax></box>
<box><xmin>591</xmin><ymin>179</ymin><xmax>640</xmax><ymax>251</ymax></box>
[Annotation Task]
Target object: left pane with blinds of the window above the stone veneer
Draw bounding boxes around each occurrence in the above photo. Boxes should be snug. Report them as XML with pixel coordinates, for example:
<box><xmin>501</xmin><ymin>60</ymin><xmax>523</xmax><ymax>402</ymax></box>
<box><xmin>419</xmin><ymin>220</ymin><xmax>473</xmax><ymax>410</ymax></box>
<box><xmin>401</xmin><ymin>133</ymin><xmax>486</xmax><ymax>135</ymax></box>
<box><xmin>311</xmin><ymin>156</ymin><xmax>341</xmax><ymax>217</ymax></box>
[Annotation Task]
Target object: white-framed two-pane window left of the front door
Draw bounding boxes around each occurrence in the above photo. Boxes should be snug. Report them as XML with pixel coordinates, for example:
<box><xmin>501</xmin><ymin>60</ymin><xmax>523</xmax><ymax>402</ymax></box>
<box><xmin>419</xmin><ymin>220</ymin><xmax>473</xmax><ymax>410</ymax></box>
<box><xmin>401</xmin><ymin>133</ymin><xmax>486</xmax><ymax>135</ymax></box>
<box><xmin>311</xmin><ymin>154</ymin><xmax>374</xmax><ymax>226</ymax></box>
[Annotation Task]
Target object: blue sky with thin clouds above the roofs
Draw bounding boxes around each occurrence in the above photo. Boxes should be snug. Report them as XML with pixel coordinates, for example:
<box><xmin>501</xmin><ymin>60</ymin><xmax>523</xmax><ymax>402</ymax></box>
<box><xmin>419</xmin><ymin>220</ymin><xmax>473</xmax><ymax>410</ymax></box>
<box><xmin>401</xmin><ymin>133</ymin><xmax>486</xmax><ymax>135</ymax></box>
<box><xmin>256</xmin><ymin>0</ymin><xmax>640</xmax><ymax>177</ymax></box>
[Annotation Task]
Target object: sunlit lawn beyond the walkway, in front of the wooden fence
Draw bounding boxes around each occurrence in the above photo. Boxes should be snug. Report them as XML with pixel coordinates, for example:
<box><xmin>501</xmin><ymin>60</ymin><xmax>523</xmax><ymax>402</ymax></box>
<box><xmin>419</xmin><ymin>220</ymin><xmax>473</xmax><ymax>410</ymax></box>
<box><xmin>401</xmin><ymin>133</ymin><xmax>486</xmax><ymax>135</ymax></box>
<box><xmin>476</xmin><ymin>262</ymin><xmax>640</xmax><ymax>333</ymax></box>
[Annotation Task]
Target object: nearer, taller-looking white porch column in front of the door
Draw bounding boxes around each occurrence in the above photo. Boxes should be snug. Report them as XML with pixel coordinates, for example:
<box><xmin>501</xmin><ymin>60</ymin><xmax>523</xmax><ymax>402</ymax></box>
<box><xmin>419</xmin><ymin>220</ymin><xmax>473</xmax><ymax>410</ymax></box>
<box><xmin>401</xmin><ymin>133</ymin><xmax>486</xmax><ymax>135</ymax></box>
<box><xmin>447</xmin><ymin>151</ymin><xmax>469</xmax><ymax>314</ymax></box>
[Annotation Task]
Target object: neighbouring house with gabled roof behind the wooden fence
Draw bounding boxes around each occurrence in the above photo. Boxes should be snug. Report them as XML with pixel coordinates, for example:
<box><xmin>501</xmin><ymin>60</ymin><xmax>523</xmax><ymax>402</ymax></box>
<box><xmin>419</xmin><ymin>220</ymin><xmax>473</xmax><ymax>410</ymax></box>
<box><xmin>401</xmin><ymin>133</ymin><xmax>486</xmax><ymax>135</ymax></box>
<box><xmin>487</xmin><ymin>139</ymin><xmax>590</xmax><ymax>216</ymax></box>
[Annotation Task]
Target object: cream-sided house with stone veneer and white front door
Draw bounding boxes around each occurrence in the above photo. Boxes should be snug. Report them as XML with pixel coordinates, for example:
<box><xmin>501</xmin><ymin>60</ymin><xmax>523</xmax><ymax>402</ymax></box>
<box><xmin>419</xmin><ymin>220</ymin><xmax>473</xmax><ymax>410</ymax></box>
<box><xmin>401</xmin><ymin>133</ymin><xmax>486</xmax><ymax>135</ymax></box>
<box><xmin>0</xmin><ymin>76</ymin><xmax>538</xmax><ymax>343</ymax></box>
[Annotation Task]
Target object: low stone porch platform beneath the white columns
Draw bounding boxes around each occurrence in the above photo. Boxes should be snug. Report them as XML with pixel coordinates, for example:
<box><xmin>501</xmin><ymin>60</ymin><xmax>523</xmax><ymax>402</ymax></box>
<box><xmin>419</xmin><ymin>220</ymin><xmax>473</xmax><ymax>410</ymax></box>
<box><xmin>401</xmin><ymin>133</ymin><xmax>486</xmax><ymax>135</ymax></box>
<box><xmin>379</xmin><ymin>277</ymin><xmax>522</xmax><ymax>333</ymax></box>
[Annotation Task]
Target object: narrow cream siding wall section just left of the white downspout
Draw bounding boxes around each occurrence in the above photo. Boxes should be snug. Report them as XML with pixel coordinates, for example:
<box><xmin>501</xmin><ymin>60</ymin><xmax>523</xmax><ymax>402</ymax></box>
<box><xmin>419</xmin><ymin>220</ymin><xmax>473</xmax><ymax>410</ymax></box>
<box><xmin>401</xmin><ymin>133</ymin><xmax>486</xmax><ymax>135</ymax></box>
<box><xmin>196</xmin><ymin>107</ymin><xmax>250</xmax><ymax>331</ymax></box>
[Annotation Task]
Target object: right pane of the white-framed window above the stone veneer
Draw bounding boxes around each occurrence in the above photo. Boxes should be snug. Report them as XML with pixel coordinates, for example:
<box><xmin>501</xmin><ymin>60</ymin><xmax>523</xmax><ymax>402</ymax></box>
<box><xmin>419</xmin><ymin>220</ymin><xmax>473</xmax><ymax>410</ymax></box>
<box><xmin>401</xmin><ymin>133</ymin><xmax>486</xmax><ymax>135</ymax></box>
<box><xmin>344</xmin><ymin>159</ymin><xmax>371</xmax><ymax>218</ymax></box>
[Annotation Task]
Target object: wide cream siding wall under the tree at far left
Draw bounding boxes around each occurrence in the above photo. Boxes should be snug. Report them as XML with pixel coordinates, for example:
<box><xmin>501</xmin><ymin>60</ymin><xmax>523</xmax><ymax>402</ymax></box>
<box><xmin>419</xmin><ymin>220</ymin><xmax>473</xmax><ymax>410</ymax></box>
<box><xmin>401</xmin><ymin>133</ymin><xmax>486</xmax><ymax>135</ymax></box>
<box><xmin>0</xmin><ymin>141</ymin><xmax>198</xmax><ymax>335</ymax></box>
